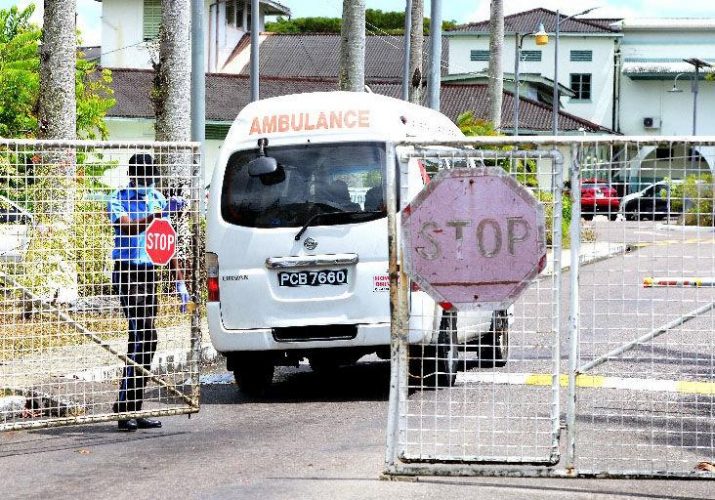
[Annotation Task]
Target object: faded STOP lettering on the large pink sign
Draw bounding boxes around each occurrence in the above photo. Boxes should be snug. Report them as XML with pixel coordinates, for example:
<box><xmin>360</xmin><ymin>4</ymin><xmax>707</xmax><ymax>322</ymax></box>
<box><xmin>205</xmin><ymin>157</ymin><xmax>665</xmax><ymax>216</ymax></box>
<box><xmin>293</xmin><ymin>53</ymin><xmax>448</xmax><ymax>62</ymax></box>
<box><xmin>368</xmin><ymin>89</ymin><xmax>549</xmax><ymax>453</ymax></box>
<box><xmin>415</xmin><ymin>217</ymin><xmax>531</xmax><ymax>260</ymax></box>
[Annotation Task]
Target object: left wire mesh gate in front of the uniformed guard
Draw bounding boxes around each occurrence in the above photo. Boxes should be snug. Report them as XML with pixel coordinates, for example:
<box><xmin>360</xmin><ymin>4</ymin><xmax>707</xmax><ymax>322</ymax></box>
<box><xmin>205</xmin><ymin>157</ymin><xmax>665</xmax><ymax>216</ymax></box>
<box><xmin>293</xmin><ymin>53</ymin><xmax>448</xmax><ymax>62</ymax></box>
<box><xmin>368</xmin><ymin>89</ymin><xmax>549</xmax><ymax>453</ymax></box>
<box><xmin>0</xmin><ymin>140</ymin><xmax>205</xmax><ymax>431</ymax></box>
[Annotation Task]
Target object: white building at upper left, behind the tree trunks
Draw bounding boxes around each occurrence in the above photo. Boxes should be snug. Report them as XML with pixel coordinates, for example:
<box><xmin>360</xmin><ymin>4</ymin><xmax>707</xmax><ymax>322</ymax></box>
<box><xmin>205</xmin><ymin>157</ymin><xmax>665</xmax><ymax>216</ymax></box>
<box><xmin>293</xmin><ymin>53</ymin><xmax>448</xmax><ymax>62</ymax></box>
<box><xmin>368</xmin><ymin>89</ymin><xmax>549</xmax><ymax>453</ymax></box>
<box><xmin>100</xmin><ymin>0</ymin><xmax>291</xmax><ymax>72</ymax></box>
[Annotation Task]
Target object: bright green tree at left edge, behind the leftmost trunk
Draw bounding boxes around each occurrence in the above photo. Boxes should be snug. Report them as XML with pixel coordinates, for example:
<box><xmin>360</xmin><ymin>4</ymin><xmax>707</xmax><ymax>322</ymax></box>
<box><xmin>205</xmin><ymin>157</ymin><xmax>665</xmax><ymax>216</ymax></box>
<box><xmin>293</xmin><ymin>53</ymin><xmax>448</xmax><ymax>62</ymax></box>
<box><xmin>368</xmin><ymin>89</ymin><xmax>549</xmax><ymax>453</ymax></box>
<box><xmin>0</xmin><ymin>4</ymin><xmax>115</xmax><ymax>139</ymax></box>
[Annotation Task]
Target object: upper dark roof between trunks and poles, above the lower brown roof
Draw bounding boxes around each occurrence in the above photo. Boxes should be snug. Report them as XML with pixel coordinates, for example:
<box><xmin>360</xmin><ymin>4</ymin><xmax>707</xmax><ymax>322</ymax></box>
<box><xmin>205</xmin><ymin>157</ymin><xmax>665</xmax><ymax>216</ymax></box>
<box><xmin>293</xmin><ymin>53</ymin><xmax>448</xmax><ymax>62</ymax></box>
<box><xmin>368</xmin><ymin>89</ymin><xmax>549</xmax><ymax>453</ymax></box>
<box><xmin>223</xmin><ymin>33</ymin><xmax>448</xmax><ymax>81</ymax></box>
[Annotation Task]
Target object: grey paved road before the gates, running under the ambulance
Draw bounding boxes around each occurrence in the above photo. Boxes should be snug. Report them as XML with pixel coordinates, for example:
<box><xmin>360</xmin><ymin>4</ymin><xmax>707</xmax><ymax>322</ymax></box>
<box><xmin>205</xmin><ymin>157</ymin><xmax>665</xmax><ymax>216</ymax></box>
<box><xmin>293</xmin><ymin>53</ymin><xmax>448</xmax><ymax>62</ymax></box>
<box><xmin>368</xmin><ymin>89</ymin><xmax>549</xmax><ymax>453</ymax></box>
<box><xmin>0</xmin><ymin>362</ymin><xmax>713</xmax><ymax>500</ymax></box>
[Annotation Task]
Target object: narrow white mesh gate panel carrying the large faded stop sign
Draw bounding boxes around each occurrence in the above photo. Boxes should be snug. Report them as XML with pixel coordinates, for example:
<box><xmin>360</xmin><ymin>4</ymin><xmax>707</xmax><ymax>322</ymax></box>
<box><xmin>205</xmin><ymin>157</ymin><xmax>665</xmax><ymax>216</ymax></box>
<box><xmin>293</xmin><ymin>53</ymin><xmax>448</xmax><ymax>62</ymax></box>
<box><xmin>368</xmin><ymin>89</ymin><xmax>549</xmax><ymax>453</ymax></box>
<box><xmin>388</xmin><ymin>140</ymin><xmax>563</xmax><ymax>473</ymax></box>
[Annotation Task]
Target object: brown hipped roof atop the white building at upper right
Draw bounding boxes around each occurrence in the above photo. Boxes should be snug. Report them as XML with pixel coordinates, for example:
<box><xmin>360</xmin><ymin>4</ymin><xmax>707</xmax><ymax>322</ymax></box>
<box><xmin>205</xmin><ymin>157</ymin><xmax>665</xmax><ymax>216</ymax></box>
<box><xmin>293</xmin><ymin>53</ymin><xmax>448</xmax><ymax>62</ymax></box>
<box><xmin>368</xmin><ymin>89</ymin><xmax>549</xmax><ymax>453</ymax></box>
<box><xmin>446</xmin><ymin>7</ymin><xmax>620</xmax><ymax>36</ymax></box>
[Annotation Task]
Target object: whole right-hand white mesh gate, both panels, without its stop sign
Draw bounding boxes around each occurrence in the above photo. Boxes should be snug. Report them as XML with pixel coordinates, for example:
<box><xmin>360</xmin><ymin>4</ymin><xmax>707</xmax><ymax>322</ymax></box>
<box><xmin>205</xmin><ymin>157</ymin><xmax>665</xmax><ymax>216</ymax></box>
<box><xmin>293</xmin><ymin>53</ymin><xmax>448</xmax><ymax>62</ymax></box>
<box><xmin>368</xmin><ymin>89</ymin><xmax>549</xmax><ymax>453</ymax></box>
<box><xmin>386</xmin><ymin>137</ymin><xmax>715</xmax><ymax>479</ymax></box>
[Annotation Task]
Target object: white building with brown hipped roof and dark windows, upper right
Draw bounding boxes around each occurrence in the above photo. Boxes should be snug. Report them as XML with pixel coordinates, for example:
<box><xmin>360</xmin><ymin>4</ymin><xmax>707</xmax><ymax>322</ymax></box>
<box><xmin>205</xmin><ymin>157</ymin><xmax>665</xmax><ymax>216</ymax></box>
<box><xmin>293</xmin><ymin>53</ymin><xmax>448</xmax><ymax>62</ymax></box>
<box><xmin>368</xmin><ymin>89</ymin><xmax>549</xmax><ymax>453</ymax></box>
<box><xmin>445</xmin><ymin>8</ymin><xmax>623</xmax><ymax>128</ymax></box>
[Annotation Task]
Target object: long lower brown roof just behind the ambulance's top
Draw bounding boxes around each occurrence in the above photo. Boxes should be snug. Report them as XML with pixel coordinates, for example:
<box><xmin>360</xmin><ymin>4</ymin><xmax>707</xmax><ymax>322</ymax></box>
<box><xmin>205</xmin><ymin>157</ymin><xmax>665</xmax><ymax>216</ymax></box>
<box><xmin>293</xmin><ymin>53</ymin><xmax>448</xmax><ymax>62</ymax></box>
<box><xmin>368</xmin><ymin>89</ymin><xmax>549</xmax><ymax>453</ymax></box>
<box><xmin>108</xmin><ymin>69</ymin><xmax>610</xmax><ymax>133</ymax></box>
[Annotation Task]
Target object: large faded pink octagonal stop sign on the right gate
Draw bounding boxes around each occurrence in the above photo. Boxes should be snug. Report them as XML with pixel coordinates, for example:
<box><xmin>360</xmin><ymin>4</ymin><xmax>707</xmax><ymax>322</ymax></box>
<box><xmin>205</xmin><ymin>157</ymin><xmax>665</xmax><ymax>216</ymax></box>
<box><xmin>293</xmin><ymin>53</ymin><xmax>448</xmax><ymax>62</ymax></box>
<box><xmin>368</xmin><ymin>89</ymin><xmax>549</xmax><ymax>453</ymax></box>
<box><xmin>402</xmin><ymin>167</ymin><xmax>546</xmax><ymax>309</ymax></box>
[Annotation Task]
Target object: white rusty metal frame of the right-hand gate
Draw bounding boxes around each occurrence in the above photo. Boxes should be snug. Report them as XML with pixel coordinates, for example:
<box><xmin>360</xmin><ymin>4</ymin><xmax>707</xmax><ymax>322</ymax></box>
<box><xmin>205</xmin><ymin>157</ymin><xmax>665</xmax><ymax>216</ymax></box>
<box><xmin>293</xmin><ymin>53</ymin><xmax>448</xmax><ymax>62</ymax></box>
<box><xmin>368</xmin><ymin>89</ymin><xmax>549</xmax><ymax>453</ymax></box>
<box><xmin>383</xmin><ymin>136</ymin><xmax>715</xmax><ymax>480</ymax></box>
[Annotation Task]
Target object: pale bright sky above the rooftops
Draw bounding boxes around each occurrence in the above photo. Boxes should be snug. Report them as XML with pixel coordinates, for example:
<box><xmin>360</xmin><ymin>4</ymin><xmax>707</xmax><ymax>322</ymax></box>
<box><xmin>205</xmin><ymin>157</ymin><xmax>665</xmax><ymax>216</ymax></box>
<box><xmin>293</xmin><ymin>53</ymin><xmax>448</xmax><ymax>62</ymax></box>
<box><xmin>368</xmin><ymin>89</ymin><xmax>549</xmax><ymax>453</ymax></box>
<box><xmin>0</xmin><ymin>0</ymin><xmax>715</xmax><ymax>45</ymax></box>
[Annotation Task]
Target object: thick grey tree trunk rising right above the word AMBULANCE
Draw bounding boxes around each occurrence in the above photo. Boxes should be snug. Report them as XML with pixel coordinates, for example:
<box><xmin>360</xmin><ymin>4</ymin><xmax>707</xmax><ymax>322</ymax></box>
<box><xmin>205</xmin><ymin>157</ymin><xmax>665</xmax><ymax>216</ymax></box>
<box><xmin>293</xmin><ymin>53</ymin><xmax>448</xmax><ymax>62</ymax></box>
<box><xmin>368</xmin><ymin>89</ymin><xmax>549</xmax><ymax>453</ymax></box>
<box><xmin>338</xmin><ymin>0</ymin><xmax>365</xmax><ymax>92</ymax></box>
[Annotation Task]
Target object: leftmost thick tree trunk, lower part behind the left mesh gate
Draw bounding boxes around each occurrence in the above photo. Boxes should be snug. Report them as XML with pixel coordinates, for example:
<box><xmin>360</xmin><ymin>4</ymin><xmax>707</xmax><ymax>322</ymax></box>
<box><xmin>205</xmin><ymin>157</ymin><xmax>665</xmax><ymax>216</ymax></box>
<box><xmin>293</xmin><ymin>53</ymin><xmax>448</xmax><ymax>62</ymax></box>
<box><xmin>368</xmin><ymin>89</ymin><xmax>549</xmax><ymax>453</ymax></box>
<box><xmin>32</xmin><ymin>0</ymin><xmax>80</xmax><ymax>304</ymax></box>
